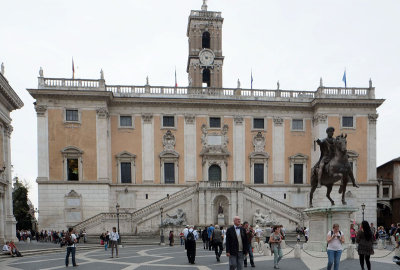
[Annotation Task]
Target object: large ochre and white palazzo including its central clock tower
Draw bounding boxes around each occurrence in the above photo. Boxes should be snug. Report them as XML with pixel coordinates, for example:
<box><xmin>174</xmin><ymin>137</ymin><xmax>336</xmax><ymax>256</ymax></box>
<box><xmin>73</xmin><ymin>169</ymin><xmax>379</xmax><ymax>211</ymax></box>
<box><xmin>28</xmin><ymin>4</ymin><xmax>383</xmax><ymax>233</ymax></box>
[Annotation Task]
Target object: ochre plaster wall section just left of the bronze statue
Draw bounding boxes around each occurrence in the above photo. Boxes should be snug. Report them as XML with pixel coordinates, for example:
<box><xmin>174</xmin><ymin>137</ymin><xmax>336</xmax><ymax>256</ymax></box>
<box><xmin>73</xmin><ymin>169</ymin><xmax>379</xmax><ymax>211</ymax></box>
<box><xmin>285</xmin><ymin>119</ymin><xmax>312</xmax><ymax>184</ymax></box>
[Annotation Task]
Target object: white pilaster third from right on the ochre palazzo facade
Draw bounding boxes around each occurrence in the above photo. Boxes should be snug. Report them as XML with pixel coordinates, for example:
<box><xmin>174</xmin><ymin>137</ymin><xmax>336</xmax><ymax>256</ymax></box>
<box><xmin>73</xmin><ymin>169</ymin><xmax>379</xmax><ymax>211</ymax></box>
<box><xmin>272</xmin><ymin>117</ymin><xmax>285</xmax><ymax>183</ymax></box>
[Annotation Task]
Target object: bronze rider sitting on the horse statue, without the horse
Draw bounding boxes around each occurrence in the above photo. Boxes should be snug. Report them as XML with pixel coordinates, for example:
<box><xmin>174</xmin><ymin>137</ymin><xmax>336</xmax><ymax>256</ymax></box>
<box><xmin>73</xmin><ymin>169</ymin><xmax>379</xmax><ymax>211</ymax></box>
<box><xmin>317</xmin><ymin>127</ymin><xmax>335</xmax><ymax>188</ymax></box>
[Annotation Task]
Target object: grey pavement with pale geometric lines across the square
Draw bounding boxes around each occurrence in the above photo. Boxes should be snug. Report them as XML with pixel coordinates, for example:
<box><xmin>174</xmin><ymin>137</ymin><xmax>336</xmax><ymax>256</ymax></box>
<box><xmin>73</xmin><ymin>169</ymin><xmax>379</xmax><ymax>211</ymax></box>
<box><xmin>0</xmin><ymin>245</ymin><xmax>400</xmax><ymax>270</ymax></box>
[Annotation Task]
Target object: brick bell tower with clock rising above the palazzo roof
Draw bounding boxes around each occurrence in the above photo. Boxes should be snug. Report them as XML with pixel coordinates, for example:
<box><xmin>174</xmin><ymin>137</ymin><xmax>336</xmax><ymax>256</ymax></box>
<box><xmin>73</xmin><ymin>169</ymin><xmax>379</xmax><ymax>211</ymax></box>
<box><xmin>186</xmin><ymin>0</ymin><xmax>224</xmax><ymax>88</ymax></box>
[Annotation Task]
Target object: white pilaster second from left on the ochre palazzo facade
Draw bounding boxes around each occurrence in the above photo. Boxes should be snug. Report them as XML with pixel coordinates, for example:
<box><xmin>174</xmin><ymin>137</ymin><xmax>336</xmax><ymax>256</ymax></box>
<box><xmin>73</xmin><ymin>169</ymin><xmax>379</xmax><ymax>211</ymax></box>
<box><xmin>96</xmin><ymin>107</ymin><xmax>110</xmax><ymax>181</ymax></box>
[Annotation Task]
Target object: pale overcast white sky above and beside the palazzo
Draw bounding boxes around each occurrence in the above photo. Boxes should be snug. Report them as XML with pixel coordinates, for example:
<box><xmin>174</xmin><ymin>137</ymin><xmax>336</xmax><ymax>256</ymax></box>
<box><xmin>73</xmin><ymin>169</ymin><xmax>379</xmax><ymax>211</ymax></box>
<box><xmin>0</xmin><ymin>0</ymin><xmax>400</xmax><ymax>207</ymax></box>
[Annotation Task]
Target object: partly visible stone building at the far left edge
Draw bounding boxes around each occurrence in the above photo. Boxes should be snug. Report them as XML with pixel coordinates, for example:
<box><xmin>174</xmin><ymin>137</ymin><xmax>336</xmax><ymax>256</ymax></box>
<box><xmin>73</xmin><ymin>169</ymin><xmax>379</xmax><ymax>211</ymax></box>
<box><xmin>0</xmin><ymin>64</ymin><xmax>24</xmax><ymax>240</ymax></box>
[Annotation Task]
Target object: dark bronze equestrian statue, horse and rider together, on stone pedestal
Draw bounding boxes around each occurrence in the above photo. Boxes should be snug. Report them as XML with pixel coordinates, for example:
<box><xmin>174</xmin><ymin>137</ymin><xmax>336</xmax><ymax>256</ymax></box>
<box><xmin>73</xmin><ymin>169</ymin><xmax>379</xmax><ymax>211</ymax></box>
<box><xmin>310</xmin><ymin>127</ymin><xmax>359</xmax><ymax>207</ymax></box>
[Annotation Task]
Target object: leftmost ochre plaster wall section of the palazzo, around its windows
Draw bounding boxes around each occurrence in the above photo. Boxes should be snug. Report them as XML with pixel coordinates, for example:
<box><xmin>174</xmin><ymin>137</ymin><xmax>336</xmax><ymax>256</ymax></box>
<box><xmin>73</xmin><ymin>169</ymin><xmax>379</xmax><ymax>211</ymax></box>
<box><xmin>48</xmin><ymin>109</ymin><xmax>97</xmax><ymax>181</ymax></box>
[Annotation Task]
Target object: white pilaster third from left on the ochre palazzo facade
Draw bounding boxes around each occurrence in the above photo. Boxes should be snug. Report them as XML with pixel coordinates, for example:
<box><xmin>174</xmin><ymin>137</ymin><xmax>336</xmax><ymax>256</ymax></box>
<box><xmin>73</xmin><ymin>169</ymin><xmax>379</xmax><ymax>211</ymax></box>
<box><xmin>142</xmin><ymin>114</ymin><xmax>155</xmax><ymax>183</ymax></box>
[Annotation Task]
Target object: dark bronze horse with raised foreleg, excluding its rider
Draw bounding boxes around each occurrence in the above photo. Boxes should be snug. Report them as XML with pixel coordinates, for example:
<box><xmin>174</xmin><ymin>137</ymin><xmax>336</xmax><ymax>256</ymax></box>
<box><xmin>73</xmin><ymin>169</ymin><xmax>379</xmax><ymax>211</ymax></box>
<box><xmin>310</xmin><ymin>134</ymin><xmax>358</xmax><ymax>207</ymax></box>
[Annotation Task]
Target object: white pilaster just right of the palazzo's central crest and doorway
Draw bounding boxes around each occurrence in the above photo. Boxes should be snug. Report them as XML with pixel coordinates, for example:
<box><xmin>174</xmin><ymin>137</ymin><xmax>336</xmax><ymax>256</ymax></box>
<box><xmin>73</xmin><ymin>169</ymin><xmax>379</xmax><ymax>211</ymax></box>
<box><xmin>233</xmin><ymin>116</ymin><xmax>246</xmax><ymax>182</ymax></box>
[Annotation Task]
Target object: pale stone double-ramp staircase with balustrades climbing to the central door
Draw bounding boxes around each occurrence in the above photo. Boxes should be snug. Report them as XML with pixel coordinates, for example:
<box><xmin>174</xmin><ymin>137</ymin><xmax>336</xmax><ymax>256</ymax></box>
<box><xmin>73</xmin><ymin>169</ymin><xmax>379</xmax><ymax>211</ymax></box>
<box><xmin>74</xmin><ymin>181</ymin><xmax>303</xmax><ymax>236</ymax></box>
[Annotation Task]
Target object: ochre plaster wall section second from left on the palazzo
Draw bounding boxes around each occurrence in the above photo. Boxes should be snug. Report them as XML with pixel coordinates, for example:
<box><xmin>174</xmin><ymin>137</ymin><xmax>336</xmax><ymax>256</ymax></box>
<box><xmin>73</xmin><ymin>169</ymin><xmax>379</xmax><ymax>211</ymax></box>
<box><xmin>110</xmin><ymin>115</ymin><xmax>142</xmax><ymax>184</ymax></box>
